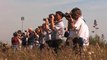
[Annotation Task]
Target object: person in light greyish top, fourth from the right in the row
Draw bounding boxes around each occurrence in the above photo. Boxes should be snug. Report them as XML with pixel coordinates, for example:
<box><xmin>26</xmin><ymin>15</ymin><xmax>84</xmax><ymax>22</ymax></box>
<box><xmin>39</xmin><ymin>23</ymin><xmax>50</xmax><ymax>50</ymax></box>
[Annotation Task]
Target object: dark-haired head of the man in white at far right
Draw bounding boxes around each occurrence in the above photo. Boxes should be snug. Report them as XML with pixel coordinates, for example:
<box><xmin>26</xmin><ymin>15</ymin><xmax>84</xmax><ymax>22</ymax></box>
<box><xmin>71</xmin><ymin>7</ymin><xmax>82</xmax><ymax>20</ymax></box>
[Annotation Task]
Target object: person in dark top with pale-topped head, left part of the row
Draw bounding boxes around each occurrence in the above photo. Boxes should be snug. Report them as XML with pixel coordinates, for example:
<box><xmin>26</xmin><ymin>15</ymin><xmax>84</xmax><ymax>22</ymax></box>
<box><xmin>28</xmin><ymin>28</ymin><xmax>35</xmax><ymax>49</ymax></box>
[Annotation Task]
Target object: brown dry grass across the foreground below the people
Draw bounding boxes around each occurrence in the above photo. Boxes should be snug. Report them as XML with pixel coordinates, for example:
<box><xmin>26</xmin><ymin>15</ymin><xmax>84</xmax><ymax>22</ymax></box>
<box><xmin>0</xmin><ymin>44</ymin><xmax>107</xmax><ymax>60</ymax></box>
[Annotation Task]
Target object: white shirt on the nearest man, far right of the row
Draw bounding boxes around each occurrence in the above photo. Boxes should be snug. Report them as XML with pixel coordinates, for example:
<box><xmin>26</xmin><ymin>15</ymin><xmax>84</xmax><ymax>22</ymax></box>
<box><xmin>75</xmin><ymin>17</ymin><xmax>89</xmax><ymax>44</ymax></box>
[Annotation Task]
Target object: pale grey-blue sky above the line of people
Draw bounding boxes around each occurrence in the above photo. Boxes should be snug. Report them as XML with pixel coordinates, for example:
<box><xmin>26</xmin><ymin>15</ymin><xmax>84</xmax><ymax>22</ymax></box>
<box><xmin>0</xmin><ymin>0</ymin><xmax>107</xmax><ymax>43</ymax></box>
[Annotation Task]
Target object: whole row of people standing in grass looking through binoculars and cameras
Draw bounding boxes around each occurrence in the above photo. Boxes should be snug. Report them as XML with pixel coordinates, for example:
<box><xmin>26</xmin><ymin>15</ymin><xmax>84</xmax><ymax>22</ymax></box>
<box><xmin>12</xmin><ymin>8</ymin><xmax>89</xmax><ymax>52</ymax></box>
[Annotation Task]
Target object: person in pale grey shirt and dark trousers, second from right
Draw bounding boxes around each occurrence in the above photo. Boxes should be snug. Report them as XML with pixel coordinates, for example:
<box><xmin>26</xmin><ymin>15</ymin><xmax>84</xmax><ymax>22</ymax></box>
<box><xmin>51</xmin><ymin>11</ymin><xmax>64</xmax><ymax>53</ymax></box>
